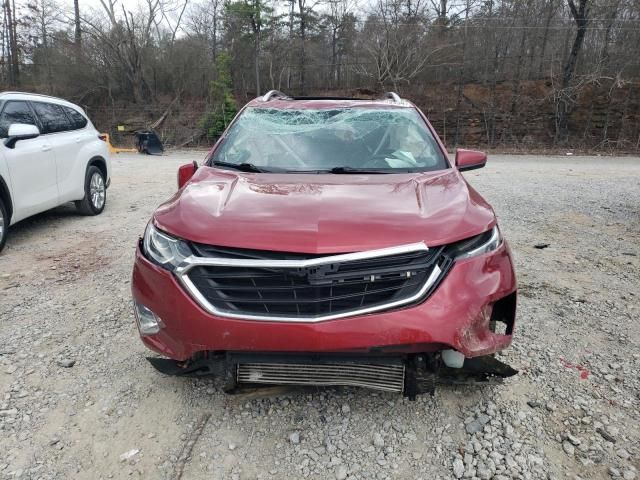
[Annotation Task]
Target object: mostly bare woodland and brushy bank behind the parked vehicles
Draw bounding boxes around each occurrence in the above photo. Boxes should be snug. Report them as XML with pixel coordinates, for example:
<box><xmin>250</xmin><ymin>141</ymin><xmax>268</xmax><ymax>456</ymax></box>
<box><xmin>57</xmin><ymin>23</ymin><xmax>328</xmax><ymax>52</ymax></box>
<box><xmin>0</xmin><ymin>0</ymin><xmax>640</xmax><ymax>152</ymax></box>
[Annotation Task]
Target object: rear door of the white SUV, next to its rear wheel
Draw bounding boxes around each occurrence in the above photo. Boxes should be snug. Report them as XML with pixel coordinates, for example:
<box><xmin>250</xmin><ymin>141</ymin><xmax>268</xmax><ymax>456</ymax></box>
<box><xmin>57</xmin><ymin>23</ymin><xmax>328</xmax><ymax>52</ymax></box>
<box><xmin>31</xmin><ymin>101</ymin><xmax>80</xmax><ymax>203</ymax></box>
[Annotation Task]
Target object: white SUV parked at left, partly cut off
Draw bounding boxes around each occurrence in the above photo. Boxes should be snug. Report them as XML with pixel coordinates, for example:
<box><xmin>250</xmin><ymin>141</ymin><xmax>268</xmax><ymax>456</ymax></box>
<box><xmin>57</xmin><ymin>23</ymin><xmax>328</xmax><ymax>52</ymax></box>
<box><xmin>0</xmin><ymin>92</ymin><xmax>111</xmax><ymax>250</ymax></box>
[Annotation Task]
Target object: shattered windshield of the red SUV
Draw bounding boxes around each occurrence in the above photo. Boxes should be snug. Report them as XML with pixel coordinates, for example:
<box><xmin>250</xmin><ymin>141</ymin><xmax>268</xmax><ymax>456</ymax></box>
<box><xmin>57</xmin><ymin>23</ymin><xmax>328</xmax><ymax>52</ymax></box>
<box><xmin>209</xmin><ymin>107</ymin><xmax>448</xmax><ymax>173</ymax></box>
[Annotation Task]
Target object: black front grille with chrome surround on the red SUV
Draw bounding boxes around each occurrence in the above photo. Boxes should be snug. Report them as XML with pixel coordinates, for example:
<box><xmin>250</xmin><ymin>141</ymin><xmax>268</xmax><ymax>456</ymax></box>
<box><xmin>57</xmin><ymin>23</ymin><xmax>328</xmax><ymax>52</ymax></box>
<box><xmin>178</xmin><ymin>244</ymin><xmax>442</xmax><ymax>321</ymax></box>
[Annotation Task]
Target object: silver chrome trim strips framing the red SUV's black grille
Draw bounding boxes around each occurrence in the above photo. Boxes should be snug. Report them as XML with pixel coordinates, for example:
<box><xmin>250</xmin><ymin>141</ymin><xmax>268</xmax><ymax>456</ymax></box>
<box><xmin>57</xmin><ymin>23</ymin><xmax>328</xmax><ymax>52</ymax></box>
<box><xmin>175</xmin><ymin>242</ymin><xmax>442</xmax><ymax>323</ymax></box>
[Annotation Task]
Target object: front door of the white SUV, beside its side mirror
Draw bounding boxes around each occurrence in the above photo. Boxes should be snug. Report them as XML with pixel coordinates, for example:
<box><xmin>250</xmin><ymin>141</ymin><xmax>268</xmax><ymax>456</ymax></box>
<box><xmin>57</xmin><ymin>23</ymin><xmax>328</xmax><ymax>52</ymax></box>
<box><xmin>0</xmin><ymin>100</ymin><xmax>58</xmax><ymax>223</ymax></box>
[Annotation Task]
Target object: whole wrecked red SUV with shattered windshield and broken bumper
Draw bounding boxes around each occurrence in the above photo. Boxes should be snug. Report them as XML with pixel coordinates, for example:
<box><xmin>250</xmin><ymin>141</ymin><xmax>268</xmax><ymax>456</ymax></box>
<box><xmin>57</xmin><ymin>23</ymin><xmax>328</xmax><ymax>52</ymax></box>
<box><xmin>132</xmin><ymin>91</ymin><xmax>516</xmax><ymax>397</ymax></box>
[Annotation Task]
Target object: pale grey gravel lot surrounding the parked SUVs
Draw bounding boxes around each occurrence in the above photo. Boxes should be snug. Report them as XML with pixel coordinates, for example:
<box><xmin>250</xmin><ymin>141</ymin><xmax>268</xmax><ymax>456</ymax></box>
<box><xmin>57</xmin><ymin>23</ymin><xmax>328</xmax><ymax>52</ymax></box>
<box><xmin>0</xmin><ymin>152</ymin><xmax>640</xmax><ymax>480</ymax></box>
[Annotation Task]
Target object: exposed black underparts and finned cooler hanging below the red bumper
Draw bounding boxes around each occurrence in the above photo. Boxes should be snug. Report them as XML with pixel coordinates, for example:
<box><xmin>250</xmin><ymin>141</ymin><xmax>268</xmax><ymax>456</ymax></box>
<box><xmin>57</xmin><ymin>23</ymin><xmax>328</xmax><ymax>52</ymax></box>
<box><xmin>148</xmin><ymin>352</ymin><xmax>517</xmax><ymax>400</ymax></box>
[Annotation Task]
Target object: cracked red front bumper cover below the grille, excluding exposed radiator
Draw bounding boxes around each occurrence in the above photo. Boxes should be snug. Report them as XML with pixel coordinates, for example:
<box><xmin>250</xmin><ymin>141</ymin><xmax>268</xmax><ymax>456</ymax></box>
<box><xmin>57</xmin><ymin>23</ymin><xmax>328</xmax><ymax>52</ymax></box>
<box><xmin>132</xmin><ymin>243</ymin><xmax>516</xmax><ymax>361</ymax></box>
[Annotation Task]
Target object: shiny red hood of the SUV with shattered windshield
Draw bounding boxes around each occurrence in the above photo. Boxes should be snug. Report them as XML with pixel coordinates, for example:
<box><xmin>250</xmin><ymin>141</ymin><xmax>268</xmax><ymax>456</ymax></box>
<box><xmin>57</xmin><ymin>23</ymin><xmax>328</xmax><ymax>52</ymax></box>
<box><xmin>154</xmin><ymin>167</ymin><xmax>495</xmax><ymax>254</ymax></box>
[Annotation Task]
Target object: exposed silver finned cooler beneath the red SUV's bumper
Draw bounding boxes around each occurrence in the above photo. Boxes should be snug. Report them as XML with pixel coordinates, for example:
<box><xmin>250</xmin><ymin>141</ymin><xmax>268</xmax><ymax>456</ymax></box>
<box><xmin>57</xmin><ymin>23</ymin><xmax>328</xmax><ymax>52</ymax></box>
<box><xmin>237</xmin><ymin>363</ymin><xmax>405</xmax><ymax>393</ymax></box>
